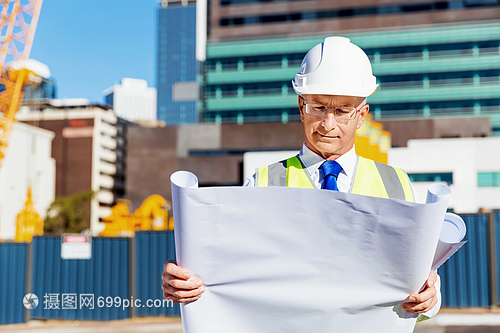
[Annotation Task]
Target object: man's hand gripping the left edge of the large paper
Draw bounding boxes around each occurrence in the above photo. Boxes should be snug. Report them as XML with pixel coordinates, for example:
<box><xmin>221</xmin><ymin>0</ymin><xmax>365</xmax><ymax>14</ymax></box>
<box><xmin>161</xmin><ymin>260</ymin><xmax>205</xmax><ymax>303</ymax></box>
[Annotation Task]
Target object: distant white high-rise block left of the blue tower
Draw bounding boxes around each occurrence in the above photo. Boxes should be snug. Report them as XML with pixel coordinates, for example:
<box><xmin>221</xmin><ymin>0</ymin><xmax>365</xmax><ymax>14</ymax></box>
<box><xmin>102</xmin><ymin>78</ymin><xmax>156</xmax><ymax>121</ymax></box>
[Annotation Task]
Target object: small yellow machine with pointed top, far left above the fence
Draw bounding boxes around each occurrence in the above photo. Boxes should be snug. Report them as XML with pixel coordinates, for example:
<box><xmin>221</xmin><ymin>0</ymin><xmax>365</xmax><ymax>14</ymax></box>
<box><xmin>14</xmin><ymin>187</ymin><xmax>43</xmax><ymax>243</ymax></box>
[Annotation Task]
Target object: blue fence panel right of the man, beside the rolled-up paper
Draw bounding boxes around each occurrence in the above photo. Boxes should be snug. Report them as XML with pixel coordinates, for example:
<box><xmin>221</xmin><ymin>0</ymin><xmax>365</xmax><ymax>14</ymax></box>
<box><xmin>438</xmin><ymin>214</ymin><xmax>490</xmax><ymax>308</ymax></box>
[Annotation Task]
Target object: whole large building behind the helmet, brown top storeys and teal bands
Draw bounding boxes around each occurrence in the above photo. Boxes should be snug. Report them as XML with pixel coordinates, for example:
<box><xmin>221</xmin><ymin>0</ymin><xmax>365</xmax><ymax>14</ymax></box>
<box><xmin>200</xmin><ymin>0</ymin><xmax>500</xmax><ymax>135</ymax></box>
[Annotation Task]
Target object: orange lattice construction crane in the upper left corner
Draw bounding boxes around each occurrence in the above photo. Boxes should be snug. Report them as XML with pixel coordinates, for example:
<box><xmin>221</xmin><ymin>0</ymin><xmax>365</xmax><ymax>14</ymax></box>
<box><xmin>0</xmin><ymin>0</ymin><xmax>42</xmax><ymax>167</ymax></box>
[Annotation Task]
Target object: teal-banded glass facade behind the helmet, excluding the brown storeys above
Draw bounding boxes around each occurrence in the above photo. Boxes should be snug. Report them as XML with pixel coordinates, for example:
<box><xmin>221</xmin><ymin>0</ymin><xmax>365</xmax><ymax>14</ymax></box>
<box><xmin>201</xmin><ymin>21</ymin><xmax>500</xmax><ymax>136</ymax></box>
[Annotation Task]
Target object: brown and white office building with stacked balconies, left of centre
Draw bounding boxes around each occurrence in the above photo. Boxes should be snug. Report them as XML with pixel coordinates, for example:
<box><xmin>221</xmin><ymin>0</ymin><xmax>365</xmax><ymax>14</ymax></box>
<box><xmin>18</xmin><ymin>99</ymin><xmax>127</xmax><ymax>235</ymax></box>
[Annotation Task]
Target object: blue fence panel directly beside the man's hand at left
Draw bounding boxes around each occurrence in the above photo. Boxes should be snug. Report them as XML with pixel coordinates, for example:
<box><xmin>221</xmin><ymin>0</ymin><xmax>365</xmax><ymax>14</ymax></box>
<box><xmin>135</xmin><ymin>231</ymin><xmax>180</xmax><ymax>316</ymax></box>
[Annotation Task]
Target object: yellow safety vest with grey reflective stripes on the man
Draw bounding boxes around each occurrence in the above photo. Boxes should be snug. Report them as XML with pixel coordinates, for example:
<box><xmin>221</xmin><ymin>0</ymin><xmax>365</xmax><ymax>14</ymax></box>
<box><xmin>255</xmin><ymin>155</ymin><xmax>415</xmax><ymax>202</ymax></box>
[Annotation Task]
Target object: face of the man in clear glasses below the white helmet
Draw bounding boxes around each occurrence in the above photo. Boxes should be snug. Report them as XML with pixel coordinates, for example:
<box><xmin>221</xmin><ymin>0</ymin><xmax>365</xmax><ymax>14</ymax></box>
<box><xmin>299</xmin><ymin>95</ymin><xmax>369</xmax><ymax>160</ymax></box>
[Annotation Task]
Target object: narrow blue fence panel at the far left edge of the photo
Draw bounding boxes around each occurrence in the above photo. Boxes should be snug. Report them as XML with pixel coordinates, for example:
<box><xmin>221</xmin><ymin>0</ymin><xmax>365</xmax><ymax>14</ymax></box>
<box><xmin>0</xmin><ymin>243</ymin><xmax>28</xmax><ymax>325</ymax></box>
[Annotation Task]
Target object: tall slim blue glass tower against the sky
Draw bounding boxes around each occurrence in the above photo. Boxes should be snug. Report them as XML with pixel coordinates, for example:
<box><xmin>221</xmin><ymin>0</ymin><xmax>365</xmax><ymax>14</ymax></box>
<box><xmin>156</xmin><ymin>0</ymin><xmax>199</xmax><ymax>125</ymax></box>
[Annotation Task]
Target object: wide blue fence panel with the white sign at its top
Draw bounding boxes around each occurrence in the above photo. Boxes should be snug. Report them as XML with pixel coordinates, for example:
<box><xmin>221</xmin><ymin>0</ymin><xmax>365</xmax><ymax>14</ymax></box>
<box><xmin>31</xmin><ymin>237</ymin><xmax>130</xmax><ymax>320</ymax></box>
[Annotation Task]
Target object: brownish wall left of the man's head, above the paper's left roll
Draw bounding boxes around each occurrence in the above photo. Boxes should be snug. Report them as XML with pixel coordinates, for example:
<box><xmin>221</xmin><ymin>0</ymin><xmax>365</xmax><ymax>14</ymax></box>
<box><xmin>126</xmin><ymin>122</ymin><xmax>304</xmax><ymax>209</ymax></box>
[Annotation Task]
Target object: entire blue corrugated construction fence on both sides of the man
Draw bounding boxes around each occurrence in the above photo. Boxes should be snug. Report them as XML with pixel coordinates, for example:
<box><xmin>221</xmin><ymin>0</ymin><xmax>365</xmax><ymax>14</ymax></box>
<box><xmin>0</xmin><ymin>211</ymin><xmax>500</xmax><ymax>324</ymax></box>
